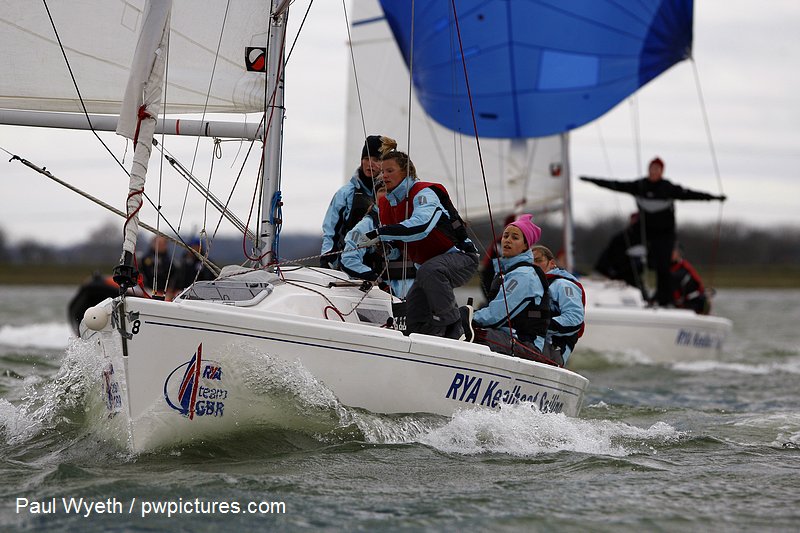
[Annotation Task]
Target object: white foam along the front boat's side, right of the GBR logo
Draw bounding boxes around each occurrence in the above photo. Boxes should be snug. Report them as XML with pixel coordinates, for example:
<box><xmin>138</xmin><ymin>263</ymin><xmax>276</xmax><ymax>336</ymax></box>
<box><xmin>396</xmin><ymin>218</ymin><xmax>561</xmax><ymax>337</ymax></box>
<box><xmin>218</xmin><ymin>345</ymin><xmax>680</xmax><ymax>456</ymax></box>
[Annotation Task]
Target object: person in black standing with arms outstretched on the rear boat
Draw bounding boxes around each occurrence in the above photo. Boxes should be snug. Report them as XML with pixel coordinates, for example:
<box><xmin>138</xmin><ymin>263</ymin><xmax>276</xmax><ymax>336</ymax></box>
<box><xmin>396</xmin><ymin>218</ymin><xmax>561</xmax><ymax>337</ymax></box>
<box><xmin>580</xmin><ymin>157</ymin><xmax>726</xmax><ymax>306</ymax></box>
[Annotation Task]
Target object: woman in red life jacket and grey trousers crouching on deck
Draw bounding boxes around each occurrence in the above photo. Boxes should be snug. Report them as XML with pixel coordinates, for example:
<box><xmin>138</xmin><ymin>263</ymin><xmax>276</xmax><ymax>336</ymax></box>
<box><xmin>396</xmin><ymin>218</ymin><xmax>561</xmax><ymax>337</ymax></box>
<box><xmin>359</xmin><ymin>151</ymin><xmax>478</xmax><ymax>339</ymax></box>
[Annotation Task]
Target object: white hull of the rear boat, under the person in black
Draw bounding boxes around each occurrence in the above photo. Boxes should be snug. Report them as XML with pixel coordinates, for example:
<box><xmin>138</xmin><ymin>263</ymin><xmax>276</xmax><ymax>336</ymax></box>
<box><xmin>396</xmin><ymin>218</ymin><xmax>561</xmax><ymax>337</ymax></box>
<box><xmin>576</xmin><ymin>279</ymin><xmax>732</xmax><ymax>363</ymax></box>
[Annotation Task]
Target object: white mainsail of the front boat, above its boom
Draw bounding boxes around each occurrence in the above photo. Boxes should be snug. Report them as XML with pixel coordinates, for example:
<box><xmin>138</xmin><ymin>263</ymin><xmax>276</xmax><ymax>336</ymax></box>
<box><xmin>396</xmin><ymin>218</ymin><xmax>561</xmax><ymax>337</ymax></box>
<box><xmin>0</xmin><ymin>0</ymin><xmax>267</xmax><ymax>114</ymax></box>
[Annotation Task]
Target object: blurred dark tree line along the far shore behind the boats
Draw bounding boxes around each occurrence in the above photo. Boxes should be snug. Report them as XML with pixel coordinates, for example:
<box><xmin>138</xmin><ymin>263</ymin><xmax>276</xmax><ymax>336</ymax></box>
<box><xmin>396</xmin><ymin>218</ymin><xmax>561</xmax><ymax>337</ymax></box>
<box><xmin>0</xmin><ymin>217</ymin><xmax>800</xmax><ymax>272</ymax></box>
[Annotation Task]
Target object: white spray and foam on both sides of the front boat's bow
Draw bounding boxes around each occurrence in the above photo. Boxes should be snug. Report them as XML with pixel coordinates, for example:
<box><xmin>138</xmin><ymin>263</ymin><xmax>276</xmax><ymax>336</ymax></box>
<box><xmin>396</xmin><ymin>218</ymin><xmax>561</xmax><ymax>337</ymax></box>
<box><xmin>0</xmin><ymin>338</ymin><xmax>681</xmax><ymax>456</ymax></box>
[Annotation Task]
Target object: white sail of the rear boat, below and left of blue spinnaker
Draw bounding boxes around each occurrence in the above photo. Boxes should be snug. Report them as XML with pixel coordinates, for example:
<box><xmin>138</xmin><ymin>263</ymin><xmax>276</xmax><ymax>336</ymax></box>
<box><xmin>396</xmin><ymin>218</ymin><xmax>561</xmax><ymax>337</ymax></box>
<box><xmin>345</xmin><ymin>0</ymin><xmax>565</xmax><ymax>222</ymax></box>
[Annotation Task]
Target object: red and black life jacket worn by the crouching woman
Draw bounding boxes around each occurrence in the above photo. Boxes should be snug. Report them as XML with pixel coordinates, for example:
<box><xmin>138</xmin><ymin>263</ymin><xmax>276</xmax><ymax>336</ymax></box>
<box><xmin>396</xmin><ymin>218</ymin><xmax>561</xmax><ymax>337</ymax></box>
<box><xmin>378</xmin><ymin>181</ymin><xmax>458</xmax><ymax>265</ymax></box>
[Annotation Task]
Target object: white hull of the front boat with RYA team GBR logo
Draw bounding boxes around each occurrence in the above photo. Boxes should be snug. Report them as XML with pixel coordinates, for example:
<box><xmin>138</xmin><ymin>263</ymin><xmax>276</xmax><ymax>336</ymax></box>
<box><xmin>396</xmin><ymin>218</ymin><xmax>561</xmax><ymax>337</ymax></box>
<box><xmin>82</xmin><ymin>269</ymin><xmax>588</xmax><ymax>451</ymax></box>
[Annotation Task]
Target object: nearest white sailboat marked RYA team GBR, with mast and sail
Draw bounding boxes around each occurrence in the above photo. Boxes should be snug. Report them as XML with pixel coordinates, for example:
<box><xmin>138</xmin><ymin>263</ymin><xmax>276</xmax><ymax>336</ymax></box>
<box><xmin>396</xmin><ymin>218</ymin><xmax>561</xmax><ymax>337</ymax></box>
<box><xmin>3</xmin><ymin>0</ymin><xmax>588</xmax><ymax>452</ymax></box>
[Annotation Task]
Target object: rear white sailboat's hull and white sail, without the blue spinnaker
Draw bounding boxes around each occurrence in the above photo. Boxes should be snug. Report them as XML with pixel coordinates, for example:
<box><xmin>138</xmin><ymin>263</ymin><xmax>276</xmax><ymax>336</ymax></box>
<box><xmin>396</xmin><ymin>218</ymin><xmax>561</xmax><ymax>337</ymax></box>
<box><xmin>344</xmin><ymin>0</ymin><xmax>732</xmax><ymax>363</ymax></box>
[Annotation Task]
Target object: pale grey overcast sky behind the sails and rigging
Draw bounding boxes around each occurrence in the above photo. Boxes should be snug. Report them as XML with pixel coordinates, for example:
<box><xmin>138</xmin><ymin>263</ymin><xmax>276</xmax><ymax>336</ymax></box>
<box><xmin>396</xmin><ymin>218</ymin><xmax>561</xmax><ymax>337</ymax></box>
<box><xmin>0</xmin><ymin>0</ymin><xmax>800</xmax><ymax>243</ymax></box>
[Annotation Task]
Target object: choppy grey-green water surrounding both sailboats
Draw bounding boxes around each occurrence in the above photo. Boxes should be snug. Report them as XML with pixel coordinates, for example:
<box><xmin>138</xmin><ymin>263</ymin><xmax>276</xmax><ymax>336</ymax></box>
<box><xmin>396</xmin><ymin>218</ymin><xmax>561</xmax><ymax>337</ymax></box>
<box><xmin>0</xmin><ymin>287</ymin><xmax>800</xmax><ymax>531</ymax></box>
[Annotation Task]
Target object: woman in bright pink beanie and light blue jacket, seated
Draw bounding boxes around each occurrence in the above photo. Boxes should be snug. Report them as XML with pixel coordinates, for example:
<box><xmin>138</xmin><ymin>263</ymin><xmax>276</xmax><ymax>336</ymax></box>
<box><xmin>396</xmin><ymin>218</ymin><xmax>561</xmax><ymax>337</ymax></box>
<box><xmin>468</xmin><ymin>215</ymin><xmax>550</xmax><ymax>360</ymax></box>
